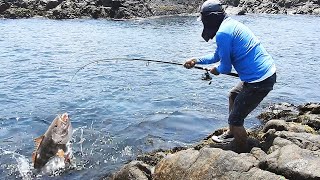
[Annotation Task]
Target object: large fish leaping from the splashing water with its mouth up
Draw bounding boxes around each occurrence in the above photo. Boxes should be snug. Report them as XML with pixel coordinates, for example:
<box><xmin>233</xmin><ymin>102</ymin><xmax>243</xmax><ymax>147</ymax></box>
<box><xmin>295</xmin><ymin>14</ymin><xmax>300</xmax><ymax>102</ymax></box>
<box><xmin>32</xmin><ymin>113</ymin><xmax>72</xmax><ymax>169</ymax></box>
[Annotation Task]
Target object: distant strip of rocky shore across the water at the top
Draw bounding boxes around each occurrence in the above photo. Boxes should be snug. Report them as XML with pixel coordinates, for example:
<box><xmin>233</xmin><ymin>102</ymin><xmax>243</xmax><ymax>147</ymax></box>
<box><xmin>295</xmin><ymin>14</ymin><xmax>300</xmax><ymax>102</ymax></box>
<box><xmin>0</xmin><ymin>0</ymin><xmax>320</xmax><ymax>19</ymax></box>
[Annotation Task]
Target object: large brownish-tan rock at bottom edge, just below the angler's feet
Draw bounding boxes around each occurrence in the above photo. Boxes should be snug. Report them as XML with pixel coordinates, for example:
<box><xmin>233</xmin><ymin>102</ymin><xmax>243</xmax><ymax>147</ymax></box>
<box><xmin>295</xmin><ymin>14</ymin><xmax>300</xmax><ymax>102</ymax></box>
<box><xmin>153</xmin><ymin>148</ymin><xmax>283</xmax><ymax>180</ymax></box>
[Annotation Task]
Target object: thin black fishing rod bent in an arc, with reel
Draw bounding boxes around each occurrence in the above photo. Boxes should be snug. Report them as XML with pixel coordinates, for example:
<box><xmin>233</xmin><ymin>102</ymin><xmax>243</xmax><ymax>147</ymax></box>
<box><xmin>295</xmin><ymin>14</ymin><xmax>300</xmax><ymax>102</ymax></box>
<box><xmin>71</xmin><ymin>58</ymin><xmax>239</xmax><ymax>80</ymax></box>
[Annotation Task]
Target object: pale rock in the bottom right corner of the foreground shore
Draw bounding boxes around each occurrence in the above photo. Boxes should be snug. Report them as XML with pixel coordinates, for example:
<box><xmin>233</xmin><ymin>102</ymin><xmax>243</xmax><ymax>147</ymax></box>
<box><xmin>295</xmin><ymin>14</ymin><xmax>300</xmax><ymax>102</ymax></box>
<box><xmin>259</xmin><ymin>144</ymin><xmax>320</xmax><ymax>180</ymax></box>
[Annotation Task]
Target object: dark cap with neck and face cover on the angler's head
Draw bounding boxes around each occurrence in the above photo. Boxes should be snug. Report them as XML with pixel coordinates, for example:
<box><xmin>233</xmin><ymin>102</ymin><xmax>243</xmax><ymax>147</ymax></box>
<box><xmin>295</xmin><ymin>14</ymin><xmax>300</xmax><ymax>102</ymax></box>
<box><xmin>199</xmin><ymin>0</ymin><xmax>226</xmax><ymax>42</ymax></box>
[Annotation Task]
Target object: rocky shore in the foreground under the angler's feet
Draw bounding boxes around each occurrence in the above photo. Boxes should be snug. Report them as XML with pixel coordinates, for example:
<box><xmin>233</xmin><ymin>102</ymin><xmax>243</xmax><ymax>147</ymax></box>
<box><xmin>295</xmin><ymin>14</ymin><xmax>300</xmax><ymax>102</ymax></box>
<box><xmin>109</xmin><ymin>103</ymin><xmax>320</xmax><ymax>180</ymax></box>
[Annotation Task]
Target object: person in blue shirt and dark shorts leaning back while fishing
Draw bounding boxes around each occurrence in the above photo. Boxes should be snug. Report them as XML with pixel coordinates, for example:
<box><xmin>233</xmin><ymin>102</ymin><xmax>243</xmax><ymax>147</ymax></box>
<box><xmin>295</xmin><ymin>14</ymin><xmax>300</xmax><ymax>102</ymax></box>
<box><xmin>184</xmin><ymin>0</ymin><xmax>276</xmax><ymax>152</ymax></box>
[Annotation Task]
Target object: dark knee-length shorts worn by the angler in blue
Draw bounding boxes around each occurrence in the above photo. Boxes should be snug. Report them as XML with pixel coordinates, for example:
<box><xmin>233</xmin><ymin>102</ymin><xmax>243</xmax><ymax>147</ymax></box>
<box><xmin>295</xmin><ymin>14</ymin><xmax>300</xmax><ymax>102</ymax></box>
<box><xmin>228</xmin><ymin>73</ymin><xmax>276</xmax><ymax>126</ymax></box>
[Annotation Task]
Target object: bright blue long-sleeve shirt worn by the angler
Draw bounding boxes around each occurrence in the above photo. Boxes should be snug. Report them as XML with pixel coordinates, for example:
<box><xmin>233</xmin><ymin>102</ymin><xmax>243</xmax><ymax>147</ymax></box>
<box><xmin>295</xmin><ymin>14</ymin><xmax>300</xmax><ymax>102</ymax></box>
<box><xmin>197</xmin><ymin>17</ymin><xmax>276</xmax><ymax>82</ymax></box>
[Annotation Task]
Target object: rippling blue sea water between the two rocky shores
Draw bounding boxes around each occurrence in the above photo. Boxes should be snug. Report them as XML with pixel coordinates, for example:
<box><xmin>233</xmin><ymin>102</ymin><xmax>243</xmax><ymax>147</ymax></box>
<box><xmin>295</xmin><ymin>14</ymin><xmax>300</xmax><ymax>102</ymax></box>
<box><xmin>0</xmin><ymin>15</ymin><xmax>320</xmax><ymax>179</ymax></box>
